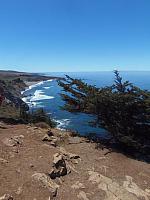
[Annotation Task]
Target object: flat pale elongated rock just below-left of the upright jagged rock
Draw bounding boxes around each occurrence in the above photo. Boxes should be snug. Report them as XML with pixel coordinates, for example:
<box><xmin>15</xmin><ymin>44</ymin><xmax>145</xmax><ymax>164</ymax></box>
<box><xmin>32</xmin><ymin>173</ymin><xmax>59</xmax><ymax>197</ymax></box>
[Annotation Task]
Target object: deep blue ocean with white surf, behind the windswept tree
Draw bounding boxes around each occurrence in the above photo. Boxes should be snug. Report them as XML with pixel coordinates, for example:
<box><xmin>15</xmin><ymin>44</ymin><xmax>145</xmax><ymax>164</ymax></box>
<box><xmin>23</xmin><ymin>71</ymin><xmax>150</xmax><ymax>137</ymax></box>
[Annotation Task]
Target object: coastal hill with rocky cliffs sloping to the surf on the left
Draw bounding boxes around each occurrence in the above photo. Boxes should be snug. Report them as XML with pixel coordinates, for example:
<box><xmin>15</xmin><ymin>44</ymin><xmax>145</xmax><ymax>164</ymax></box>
<box><xmin>0</xmin><ymin>70</ymin><xmax>61</xmax><ymax>118</ymax></box>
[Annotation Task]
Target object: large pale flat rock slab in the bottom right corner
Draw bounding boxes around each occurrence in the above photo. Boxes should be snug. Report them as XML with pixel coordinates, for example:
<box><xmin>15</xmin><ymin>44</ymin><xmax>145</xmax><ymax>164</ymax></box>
<box><xmin>89</xmin><ymin>171</ymin><xmax>150</xmax><ymax>200</ymax></box>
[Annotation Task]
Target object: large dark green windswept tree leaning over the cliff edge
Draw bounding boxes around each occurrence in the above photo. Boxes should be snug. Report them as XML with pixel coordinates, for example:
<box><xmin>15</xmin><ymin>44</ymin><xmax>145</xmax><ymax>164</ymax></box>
<box><xmin>59</xmin><ymin>71</ymin><xmax>150</xmax><ymax>153</ymax></box>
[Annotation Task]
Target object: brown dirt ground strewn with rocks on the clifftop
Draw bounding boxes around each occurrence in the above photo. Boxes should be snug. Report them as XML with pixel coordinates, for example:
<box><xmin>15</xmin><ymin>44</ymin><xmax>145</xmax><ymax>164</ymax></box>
<box><xmin>0</xmin><ymin>123</ymin><xmax>150</xmax><ymax>200</ymax></box>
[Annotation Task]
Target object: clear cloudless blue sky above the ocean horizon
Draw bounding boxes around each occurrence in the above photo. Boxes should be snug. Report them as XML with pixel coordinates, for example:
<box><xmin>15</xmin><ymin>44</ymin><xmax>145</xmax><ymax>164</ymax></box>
<box><xmin>0</xmin><ymin>0</ymin><xmax>150</xmax><ymax>72</ymax></box>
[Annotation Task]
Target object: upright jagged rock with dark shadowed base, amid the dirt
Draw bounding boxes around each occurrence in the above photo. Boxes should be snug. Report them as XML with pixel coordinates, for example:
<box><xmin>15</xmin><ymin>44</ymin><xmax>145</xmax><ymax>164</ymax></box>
<box><xmin>49</xmin><ymin>153</ymin><xmax>69</xmax><ymax>179</ymax></box>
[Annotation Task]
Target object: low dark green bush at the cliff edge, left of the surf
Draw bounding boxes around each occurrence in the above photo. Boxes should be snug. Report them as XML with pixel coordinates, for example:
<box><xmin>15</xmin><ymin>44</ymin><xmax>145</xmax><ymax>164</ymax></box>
<box><xmin>20</xmin><ymin>109</ymin><xmax>56</xmax><ymax>128</ymax></box>
